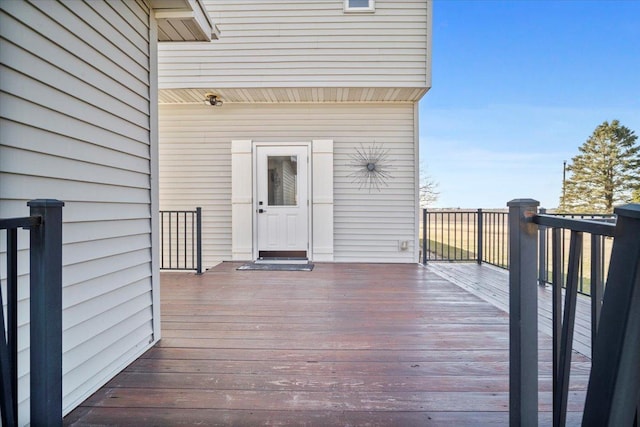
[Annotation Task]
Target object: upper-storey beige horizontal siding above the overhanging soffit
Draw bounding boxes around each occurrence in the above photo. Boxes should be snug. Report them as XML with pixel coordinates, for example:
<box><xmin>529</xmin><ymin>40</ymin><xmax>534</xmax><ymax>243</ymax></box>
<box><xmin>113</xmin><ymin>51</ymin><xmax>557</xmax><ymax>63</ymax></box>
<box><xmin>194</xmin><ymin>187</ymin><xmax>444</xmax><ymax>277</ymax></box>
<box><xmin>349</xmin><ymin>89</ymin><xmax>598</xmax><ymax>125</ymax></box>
<box><xmin>159</xmin><ymin>0</ymin><xmax>430</xmax><ymax>89</ymax></box>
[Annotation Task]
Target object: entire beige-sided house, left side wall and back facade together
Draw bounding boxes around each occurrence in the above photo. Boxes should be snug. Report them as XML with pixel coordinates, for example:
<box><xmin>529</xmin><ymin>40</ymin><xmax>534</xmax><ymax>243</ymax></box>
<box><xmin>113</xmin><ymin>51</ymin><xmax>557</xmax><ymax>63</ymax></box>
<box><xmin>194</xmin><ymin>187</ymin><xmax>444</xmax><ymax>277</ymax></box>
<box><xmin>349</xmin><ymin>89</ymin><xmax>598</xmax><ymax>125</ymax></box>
<box><xmin>0</xmin><ymin>0</ymin><xmax>431</xmax><ymax>424</ymax></box>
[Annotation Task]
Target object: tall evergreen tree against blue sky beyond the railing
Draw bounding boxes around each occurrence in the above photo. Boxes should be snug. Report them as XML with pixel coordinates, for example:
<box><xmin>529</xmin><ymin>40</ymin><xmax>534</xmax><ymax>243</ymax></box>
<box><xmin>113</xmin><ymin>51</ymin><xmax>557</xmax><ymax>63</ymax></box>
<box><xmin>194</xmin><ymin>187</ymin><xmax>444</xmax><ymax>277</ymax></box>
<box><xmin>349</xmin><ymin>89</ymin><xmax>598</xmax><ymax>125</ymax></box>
<box><xmin>559</xmin><ymin>120</ymin><xmax>640</xmax><ymax>213</ymax></box>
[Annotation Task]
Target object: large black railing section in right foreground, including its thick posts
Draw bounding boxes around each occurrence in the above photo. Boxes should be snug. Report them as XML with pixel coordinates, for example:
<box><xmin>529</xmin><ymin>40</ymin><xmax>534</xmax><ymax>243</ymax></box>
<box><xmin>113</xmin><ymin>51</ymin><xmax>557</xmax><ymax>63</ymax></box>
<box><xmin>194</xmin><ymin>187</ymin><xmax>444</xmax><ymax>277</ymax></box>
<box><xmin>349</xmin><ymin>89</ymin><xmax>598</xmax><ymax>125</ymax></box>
<box><xmin>509</xmin><ymin>199</ymin><xmax>640</xmax><ymax>426</ymax></box>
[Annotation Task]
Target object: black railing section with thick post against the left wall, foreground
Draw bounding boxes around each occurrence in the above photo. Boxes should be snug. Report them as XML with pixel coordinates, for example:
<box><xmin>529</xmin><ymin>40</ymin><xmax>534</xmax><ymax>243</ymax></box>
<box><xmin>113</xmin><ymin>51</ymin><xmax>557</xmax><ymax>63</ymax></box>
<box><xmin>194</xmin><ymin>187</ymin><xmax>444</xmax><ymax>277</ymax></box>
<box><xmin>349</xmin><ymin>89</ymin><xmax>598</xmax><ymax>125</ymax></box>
<box><xmin>0</xmin><ymin>199</ymin><xmax>64</xmax><ymax>426</ymax></box>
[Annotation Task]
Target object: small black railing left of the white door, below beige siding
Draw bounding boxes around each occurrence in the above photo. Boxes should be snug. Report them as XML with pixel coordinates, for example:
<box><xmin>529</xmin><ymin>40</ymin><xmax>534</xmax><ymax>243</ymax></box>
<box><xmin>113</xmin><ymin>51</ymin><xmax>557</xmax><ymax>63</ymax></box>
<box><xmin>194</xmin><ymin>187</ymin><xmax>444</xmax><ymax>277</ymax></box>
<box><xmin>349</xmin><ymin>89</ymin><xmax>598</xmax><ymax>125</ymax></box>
<box><xmin>160</xmin><ymin>207</ymin><xmax>202</xmax><ymax>274</ymax></box>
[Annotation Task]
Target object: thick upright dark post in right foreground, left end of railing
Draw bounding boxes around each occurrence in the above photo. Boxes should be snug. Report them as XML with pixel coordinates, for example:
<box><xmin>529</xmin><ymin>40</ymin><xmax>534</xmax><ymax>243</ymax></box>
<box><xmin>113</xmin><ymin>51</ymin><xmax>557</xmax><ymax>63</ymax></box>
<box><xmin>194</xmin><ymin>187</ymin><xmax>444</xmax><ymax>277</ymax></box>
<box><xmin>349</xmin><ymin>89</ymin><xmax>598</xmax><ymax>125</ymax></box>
<box><xmin>507</xmin><ymin>199</ymin><xmax>540</xmax><ymax>426</ymax></box>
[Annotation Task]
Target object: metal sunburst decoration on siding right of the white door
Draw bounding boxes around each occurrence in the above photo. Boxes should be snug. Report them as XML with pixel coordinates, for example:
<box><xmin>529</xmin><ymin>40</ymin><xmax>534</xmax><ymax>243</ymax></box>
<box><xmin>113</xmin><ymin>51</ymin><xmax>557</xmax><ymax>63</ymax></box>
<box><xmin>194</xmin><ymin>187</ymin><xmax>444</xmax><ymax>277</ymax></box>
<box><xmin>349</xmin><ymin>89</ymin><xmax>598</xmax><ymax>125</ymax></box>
<box><xmin>348</xmin><ymin>143</ymin><xmax>393</xmax><ymax>193</ymax></box>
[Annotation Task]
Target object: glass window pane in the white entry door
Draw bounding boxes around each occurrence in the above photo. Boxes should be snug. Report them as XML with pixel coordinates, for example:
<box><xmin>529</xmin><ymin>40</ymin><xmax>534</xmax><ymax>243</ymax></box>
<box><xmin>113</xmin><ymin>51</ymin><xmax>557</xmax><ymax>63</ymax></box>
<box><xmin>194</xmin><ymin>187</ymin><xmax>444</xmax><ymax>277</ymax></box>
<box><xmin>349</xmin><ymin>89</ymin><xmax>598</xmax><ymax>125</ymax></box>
<box><xmin>267</xmin><ymin>156</ymin><xmax>298</xmax><ymax>206</ymax></box>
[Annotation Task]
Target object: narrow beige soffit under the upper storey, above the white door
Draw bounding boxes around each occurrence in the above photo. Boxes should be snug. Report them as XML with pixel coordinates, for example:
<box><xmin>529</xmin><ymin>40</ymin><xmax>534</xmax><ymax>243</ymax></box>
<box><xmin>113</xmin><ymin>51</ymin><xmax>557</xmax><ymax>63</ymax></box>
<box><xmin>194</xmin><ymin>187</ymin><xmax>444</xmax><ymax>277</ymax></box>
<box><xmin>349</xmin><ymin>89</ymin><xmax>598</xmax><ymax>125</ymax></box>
<box><xmin>158</xmin><ymin>87</ymin><xmax>427</xmax><ymax>104</ymax></box>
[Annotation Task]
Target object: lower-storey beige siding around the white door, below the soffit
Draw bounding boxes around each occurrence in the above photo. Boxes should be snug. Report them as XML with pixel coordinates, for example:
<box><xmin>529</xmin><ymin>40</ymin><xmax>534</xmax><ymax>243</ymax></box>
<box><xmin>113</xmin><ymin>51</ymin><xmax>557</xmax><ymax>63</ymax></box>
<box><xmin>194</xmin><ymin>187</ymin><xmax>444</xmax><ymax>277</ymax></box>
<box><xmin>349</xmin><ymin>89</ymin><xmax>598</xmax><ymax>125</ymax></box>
<box><xmin>160</xmin><ymin>103</ymin><xmax>417</xmax><ymax>268</ymax></box>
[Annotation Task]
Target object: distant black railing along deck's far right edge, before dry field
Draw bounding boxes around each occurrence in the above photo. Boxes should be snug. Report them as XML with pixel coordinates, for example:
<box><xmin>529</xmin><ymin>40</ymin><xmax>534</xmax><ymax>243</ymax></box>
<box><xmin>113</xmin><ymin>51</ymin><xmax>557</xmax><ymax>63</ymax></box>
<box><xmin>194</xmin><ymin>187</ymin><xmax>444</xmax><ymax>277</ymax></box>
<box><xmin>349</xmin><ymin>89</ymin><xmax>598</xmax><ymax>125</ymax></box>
<box><xmin>421</xmin><ymin>209</ymin><xmax>615</xmax><ymax>295</ymax></box>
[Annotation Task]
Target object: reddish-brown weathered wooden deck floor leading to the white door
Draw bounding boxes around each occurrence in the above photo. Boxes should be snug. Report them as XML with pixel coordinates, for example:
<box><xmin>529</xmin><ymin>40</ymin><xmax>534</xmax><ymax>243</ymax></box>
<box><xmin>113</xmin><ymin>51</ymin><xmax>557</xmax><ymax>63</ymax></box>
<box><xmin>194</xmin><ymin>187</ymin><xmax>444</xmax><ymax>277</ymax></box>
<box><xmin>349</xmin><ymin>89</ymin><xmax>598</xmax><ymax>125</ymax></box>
<box><xmin>64</xmin><ymin>263</ymin><xmax>589</xmax><ymax>427</ymax></box>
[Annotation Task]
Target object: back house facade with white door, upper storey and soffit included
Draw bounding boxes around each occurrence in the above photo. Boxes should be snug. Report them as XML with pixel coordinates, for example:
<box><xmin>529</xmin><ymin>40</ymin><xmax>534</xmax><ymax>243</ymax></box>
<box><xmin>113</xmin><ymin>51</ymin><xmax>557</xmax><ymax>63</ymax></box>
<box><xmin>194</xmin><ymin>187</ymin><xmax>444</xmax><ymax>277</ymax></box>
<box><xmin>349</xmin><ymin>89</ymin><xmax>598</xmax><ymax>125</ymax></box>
<box><xmin>159</xmin><ymin>0</ymin><xmax>432</xmax><ymax>267</ymax></box>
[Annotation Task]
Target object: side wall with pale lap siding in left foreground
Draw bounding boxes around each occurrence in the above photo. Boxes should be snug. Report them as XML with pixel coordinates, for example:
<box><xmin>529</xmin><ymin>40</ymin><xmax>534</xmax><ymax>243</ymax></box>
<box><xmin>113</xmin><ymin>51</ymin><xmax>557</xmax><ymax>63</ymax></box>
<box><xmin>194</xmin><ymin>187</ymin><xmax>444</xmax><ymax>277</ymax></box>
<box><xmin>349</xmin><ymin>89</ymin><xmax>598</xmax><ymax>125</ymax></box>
<box><xmin>0</xmin><ymin>1</ymin><xmax>159</xmax><ymax>424</ymax></box>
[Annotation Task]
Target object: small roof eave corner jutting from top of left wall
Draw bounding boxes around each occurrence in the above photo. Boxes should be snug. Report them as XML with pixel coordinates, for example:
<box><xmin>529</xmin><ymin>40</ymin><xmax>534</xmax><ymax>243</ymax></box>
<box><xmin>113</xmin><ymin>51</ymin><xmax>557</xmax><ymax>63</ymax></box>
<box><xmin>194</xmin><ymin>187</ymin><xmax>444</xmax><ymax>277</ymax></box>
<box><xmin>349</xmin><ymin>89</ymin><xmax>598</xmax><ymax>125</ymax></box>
<box><xmin>150</xmin><ymin>0</ymin><xmax>220</xmax><ymax>42</ymax></box>
